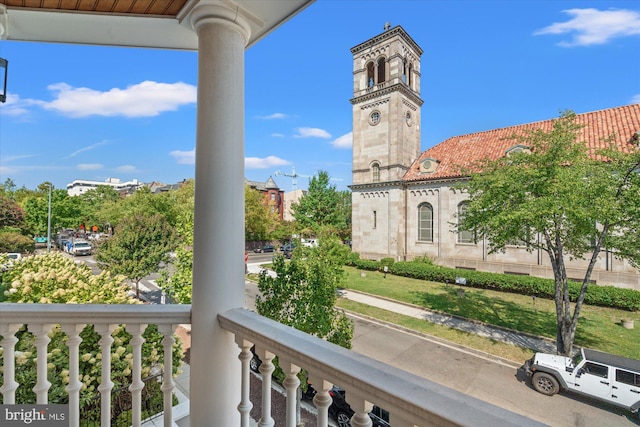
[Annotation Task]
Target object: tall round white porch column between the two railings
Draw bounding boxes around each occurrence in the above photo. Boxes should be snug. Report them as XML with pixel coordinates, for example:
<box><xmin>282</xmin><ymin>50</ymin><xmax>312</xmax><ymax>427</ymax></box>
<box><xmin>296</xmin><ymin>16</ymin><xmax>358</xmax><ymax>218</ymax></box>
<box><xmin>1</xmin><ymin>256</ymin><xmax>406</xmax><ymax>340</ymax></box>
<box><xmin>190</xmin><ymin>3</ymin><xmax>250</xmax><ymax>426</ymax></box>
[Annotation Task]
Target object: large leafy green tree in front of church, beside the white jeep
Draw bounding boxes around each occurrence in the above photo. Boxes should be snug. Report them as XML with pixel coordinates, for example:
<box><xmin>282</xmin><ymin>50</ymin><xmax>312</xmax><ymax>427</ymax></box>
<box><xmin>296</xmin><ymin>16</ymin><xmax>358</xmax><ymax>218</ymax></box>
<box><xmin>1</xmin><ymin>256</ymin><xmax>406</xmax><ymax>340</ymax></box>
<box><xmin>458</xmin><ymin>111</ymin><xmax>640</xmax><ymax>355</ymax></box>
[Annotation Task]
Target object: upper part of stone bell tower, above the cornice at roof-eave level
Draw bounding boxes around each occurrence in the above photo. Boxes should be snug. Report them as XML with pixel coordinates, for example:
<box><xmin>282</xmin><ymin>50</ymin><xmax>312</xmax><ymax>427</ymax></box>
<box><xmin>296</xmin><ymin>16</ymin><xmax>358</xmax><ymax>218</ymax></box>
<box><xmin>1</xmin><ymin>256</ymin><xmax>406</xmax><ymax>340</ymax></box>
<box><xmin>351</xmin><ymin>24</ymin><xmax>423</xmax><ymax>185</ymax></box>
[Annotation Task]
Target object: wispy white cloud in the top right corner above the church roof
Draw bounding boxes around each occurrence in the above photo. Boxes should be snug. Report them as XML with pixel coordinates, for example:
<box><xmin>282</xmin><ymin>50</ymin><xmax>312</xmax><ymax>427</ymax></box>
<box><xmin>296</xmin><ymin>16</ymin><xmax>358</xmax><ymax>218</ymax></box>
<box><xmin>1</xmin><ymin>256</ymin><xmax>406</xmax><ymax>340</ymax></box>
<box><xmin>533</xmin><ymin>8</ymin><xmax>640</xmax><ymax>47</ymax></box>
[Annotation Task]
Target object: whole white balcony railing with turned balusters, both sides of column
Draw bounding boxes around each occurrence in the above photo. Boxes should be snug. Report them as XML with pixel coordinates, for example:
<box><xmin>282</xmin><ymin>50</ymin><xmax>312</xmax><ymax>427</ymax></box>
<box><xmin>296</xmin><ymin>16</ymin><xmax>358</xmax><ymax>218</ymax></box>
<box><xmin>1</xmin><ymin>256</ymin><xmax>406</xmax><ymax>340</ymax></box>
<box><xmin>0</xmin><ymin>304</ymin><xmax>540</xmax><ymax>427</ymax></box>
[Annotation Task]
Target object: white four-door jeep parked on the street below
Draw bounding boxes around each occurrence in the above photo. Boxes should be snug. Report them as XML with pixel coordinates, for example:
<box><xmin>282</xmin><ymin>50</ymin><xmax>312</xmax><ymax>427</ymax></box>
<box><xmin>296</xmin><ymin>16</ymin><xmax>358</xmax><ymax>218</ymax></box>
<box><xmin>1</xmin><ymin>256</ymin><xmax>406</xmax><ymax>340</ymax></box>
<box><xmin>524</xmin><ymin>349</ymin><xmax>640</xmax><ymax>418</ymax></box>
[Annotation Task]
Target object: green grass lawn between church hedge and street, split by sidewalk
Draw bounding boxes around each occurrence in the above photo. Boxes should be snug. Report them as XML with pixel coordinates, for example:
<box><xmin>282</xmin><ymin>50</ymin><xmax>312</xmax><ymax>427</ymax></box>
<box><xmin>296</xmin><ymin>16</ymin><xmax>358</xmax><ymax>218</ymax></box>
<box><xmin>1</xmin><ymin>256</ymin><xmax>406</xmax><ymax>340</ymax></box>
<box><xmin>339</xmin><ymin>267</ymin><xmax>640</xmax><ymax>361</ymax></box>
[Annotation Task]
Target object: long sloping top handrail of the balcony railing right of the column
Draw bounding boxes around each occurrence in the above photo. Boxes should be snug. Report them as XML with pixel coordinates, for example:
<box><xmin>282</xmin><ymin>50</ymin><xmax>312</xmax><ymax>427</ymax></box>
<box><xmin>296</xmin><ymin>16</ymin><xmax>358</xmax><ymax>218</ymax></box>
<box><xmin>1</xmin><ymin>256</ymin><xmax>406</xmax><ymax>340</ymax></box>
<box><xmin>218</xmin><ymin>308</ymin><xmax>542</xmax><ymax>426</ymax></box>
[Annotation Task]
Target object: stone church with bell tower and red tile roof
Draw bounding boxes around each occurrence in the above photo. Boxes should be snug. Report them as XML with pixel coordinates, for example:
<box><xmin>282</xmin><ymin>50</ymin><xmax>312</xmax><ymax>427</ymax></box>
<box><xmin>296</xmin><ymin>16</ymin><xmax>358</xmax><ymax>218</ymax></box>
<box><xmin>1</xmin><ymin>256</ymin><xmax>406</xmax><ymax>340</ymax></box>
<box><xmin>351</xmin><ymin>26</ymin><xmax>640</xmax><ymax>290</ymax></box>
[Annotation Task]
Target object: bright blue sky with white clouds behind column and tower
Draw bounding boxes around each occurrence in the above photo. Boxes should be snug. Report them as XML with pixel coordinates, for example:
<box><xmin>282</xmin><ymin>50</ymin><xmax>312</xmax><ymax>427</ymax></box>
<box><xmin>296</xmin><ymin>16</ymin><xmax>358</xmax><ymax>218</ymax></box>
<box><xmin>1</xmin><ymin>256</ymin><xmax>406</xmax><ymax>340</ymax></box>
<box><xmin>0</xmin><ymin>0</ymin><xmax>640</xmax><ymax>191</ymax></box>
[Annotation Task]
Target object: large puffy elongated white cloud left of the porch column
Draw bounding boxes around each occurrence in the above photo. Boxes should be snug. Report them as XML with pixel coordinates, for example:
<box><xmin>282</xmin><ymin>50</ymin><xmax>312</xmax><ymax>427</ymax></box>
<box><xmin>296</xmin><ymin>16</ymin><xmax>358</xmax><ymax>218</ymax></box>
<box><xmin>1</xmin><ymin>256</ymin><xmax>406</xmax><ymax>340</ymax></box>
<box><xmin>42</xmin><ymin>81</ymin><xmax>196</xmax><ymax>117</ymax></box>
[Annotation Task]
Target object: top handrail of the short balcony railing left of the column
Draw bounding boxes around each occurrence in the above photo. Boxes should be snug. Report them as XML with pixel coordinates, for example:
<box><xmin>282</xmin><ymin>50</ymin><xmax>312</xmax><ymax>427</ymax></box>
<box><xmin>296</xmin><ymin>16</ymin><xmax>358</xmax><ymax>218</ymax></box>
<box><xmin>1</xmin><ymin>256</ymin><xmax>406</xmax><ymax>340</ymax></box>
<box><xmin>0</xmin><ymin>303</ymin><xmax>191</xmax><ymax>325</ymax></box>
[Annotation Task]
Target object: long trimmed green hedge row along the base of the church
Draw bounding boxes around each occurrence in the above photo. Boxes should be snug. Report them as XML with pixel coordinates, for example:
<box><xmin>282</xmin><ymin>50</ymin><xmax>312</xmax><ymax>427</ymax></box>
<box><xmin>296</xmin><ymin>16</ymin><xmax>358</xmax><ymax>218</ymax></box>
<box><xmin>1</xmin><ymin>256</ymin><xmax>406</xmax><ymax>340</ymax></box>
<box><xmin>348</xmin><ymin>258</ymin><xmax>640</xmax><ymax>311</ymax></box>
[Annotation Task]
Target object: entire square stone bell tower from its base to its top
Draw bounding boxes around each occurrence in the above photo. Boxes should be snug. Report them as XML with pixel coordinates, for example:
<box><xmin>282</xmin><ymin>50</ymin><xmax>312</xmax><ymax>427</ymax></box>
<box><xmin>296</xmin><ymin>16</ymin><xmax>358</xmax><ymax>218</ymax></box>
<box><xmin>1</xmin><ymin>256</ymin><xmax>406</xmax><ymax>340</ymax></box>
<box><xmin>350</xmin><ymin>24</ymin><xmax>422</xmax><ymax>260</ymax></box>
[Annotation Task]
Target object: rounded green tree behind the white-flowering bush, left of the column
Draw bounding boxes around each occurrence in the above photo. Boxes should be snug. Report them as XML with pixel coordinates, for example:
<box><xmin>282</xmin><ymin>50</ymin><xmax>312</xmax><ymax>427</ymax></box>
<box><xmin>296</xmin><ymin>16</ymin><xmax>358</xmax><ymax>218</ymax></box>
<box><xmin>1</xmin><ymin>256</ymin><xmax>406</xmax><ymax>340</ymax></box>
<box><xmin>96</xmin><ymin>214</ymin><xmax>176</xmax><ymax>297</ymax></box>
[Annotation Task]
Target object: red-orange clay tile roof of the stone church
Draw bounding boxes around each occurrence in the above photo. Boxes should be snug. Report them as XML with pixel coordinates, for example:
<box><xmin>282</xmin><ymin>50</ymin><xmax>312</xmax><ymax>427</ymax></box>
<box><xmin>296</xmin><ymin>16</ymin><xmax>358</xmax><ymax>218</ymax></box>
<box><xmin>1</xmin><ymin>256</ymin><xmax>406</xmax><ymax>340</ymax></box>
<box><xmin>403</xmin><ymin>104</ymin><xmax>640</xmax><ymax>181</ymax></box>
